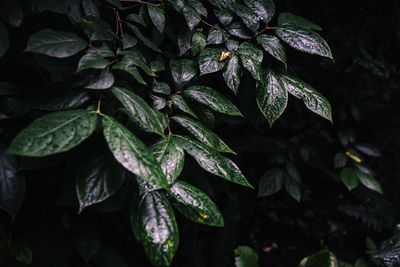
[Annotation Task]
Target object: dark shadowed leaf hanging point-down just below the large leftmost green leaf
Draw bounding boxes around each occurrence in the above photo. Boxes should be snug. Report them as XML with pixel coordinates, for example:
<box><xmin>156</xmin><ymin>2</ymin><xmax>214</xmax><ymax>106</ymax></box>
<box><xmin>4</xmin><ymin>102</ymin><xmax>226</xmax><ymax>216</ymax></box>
<box><xmin>75</xmin><ymin>153</ymin><xmax>124</xmax><ymax>212</ymax></box>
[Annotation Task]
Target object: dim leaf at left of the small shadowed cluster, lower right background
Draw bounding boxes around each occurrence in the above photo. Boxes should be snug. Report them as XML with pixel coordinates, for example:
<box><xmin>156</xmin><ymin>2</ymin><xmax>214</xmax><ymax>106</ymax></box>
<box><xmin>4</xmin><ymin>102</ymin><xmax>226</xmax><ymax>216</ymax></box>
<box><xmin>258</xmin><ymin>169</ymin><xmax>285</xmax><ymax>197</ymax></box>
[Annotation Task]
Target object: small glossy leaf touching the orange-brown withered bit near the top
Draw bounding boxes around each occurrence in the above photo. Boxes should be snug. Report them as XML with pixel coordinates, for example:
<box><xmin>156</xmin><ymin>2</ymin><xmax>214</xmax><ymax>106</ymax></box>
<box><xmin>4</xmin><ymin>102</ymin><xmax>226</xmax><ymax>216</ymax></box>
<box><xmin>198</xmin><ymin>48</ymin><xmax>225</xmax><ymax>75</ymax></box>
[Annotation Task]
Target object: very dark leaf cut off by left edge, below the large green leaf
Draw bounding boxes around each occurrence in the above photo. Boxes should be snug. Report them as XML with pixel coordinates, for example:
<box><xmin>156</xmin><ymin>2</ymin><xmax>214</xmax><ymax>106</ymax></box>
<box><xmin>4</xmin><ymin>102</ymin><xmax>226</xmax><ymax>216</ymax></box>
<box><xmin>0</xmin><ymin>145</ymin><xmax>26</xmax><ymax>217</ymax></box>
